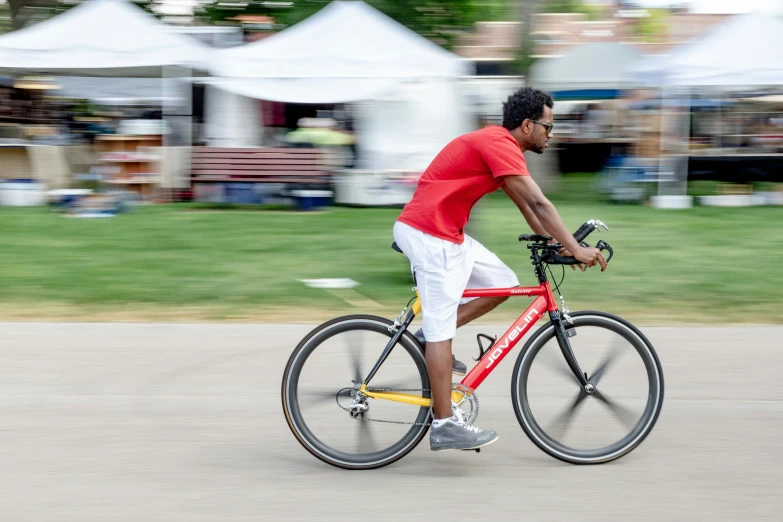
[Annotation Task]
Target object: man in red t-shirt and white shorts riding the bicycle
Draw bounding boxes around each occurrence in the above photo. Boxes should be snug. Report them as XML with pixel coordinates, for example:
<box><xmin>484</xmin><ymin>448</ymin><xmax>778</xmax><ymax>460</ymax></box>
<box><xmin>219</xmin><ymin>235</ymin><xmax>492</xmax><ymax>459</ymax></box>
<box><xmin>393</xmin><ymin>87</ymin><xmax>606</xmax><ymax>450</ymax></box>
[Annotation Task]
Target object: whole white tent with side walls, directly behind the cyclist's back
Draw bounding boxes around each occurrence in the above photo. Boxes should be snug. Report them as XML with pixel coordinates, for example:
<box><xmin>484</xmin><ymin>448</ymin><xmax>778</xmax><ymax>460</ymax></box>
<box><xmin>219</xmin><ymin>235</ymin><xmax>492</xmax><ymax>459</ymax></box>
<box><xmin>207</xmin><ymin>1</ymin><xmax>471</xmax><ymax>169</ymax></box>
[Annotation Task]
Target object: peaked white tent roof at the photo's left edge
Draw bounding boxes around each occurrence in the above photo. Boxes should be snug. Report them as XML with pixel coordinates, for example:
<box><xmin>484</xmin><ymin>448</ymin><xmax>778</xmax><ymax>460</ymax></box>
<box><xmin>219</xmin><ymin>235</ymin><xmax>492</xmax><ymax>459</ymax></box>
<box><xmin>0</xmin><ymin>0</ymin><xmax>210</xmax><ymax>77</ymax></box>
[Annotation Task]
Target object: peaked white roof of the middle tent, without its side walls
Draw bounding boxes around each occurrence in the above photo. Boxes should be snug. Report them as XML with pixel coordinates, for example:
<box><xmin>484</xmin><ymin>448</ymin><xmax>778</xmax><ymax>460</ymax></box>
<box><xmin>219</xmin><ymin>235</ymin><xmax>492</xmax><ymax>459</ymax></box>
<box><xmin>211</xmin><ymin>2</ymin><xmax>470</xmax><ymax>79</ymax></box>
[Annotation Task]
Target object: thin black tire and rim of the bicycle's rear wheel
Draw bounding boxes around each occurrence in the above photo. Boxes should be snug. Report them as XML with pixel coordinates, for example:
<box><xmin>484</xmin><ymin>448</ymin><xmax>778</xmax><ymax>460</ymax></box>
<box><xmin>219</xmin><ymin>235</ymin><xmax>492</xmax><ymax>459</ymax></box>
<box><xmin>281</xmin><ymin>314</ymin><xmax>430</xmax><ymax>470</ymax></box>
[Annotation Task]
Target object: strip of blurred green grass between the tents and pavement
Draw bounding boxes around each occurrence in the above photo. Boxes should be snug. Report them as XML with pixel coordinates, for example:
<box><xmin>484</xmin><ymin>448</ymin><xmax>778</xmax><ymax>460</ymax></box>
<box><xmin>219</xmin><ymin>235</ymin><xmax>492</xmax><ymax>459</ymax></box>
<box><xmin>0</xmin><ymin>175</ymin><xmax>783</xmax><ymax>323</ymax></box>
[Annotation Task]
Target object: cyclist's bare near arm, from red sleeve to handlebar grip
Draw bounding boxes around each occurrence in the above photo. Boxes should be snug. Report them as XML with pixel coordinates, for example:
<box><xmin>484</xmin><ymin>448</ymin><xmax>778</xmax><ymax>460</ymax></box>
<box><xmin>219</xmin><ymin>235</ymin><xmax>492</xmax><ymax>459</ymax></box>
<box><xmin>503</xmin><ymin>176</ymin><xmax>606</xmax><ymax>271</ymax></box>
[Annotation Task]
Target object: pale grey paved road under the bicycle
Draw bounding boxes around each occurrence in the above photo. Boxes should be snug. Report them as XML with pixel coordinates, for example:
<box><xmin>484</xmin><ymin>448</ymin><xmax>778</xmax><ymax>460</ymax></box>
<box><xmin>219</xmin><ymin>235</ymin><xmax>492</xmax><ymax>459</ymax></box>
<box><xmin>0</xmin><ymin>324</ymin><xmax>783</xmax><ymax>522</ymax></box>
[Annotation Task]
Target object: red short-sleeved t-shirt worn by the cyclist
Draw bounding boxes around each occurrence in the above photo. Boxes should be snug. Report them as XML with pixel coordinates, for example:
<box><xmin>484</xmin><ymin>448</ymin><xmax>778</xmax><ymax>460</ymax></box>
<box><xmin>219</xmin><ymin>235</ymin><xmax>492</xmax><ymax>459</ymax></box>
<box><xmin>397</xmin><ymin>125</ymin><xmax>530</xmax><ymax>244</ymax></box>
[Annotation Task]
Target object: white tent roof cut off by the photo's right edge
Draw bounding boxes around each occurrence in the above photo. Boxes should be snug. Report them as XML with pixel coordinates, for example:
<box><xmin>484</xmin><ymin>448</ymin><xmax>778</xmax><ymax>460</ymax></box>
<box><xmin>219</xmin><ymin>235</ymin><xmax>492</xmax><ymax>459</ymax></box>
<box><xmin>630</xmin><ymin>14</ymin><xmax>783</xmax><ymax>87</ymax></box>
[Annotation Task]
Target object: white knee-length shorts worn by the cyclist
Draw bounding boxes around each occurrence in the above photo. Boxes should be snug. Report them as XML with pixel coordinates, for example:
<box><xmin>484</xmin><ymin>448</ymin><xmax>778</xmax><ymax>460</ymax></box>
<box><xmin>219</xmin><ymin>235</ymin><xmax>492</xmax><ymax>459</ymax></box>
<box><xmin>394</xmin><ymin>221</ymin><xmax>519</xmax><ymax>342</ymax></box>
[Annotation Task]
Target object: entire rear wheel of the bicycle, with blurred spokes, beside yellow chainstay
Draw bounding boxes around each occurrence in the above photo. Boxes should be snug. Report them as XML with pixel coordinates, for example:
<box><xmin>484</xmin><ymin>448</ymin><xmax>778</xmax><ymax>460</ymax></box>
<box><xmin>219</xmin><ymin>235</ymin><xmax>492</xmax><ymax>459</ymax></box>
<box><xmin>282</xmin><ymin>315</ymin><xmax>430</xmax><ymax>469</ymax></box>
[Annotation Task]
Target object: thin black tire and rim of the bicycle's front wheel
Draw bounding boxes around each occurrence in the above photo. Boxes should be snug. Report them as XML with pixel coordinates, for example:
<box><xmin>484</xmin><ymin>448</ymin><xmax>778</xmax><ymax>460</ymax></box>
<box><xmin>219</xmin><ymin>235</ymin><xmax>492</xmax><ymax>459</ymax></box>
<box><xmin>511</xmin><ymin>310</ymin><xmax>664</xmax><ymax>465</ymax></box>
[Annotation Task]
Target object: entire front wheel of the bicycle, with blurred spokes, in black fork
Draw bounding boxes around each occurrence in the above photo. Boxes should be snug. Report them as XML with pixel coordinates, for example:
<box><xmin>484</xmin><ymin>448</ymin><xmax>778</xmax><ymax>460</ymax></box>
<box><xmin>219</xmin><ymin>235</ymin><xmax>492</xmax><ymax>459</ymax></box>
<box><xmin>511</xmin><ymin>312</ymin><xmax>663</xmax><ymax>464</ymax></box>
